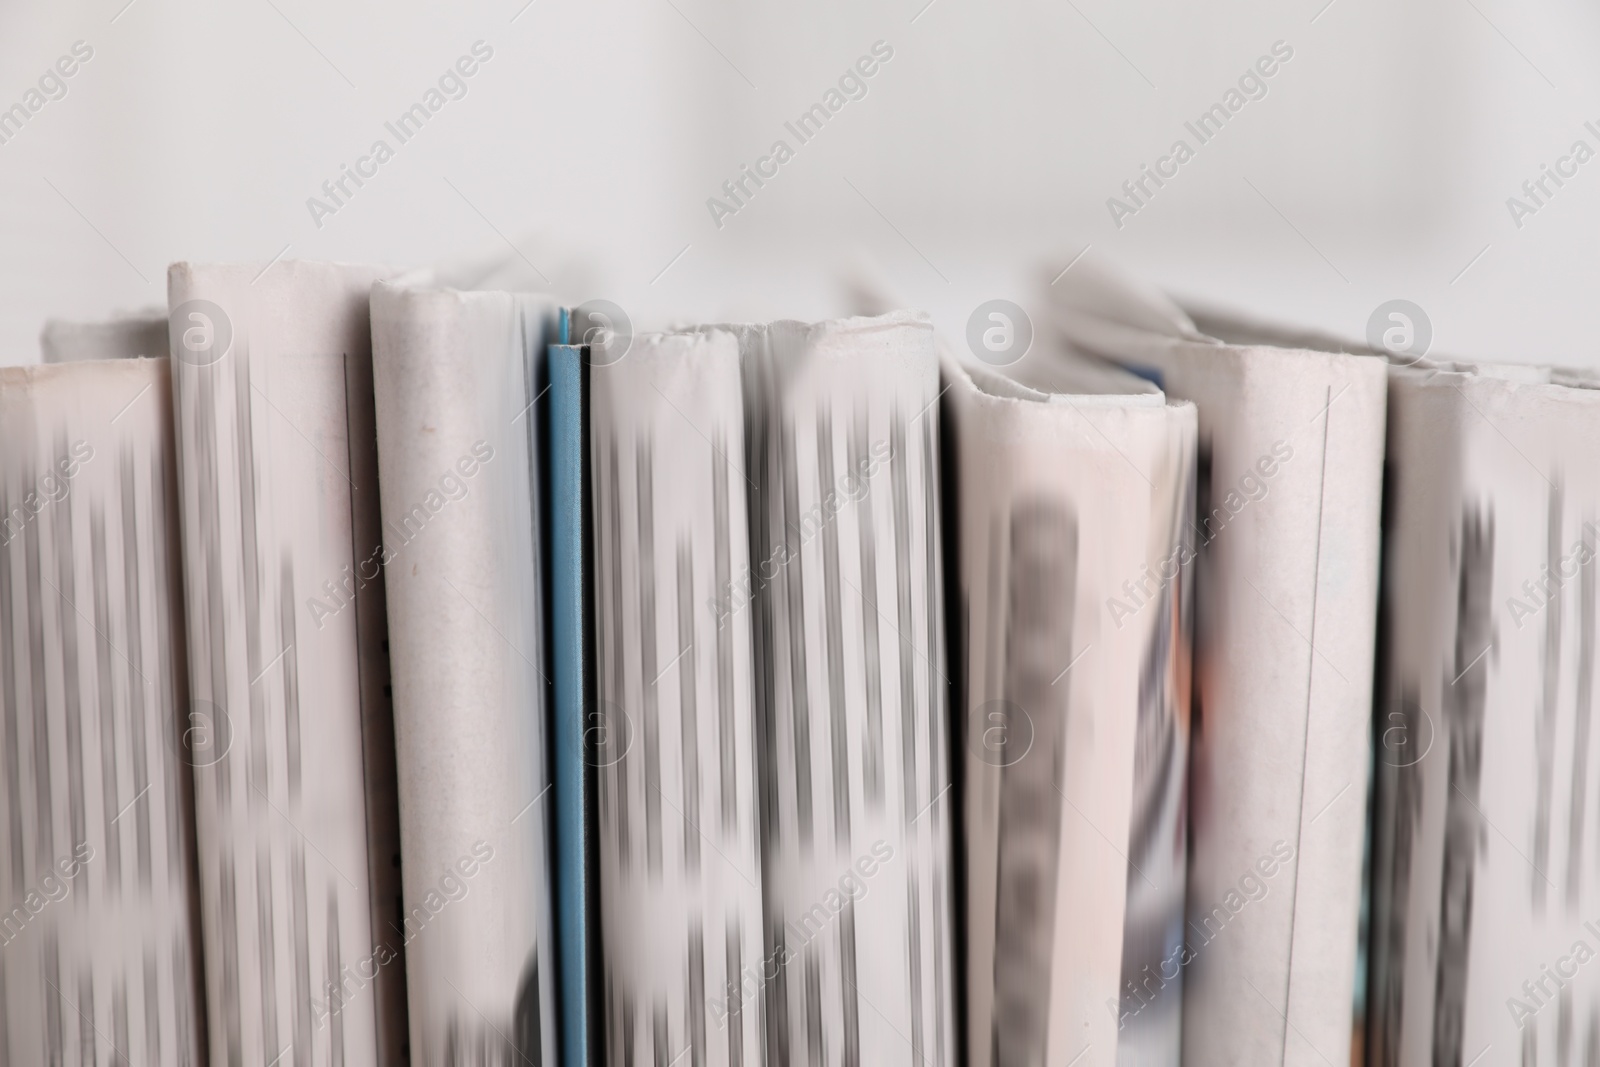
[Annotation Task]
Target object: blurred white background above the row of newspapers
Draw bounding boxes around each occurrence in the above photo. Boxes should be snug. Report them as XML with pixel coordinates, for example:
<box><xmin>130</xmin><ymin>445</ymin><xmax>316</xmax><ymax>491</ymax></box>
<box><xmin>0</xmin><ymin>0</ymin><xmax>1600</xmax><ymax>365</ymax></box>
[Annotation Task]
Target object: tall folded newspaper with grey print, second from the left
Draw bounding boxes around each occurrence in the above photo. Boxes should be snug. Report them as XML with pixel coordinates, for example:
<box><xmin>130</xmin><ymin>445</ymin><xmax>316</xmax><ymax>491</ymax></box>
<box><xmin>168</xmin><ymin>261</ymin><xmax>405</xmax><ymax>1067</ymax></box>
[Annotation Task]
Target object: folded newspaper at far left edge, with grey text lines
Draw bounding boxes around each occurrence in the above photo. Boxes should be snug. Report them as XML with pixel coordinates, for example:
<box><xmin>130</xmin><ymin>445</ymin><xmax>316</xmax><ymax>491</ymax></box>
<box><xmin>0</xmin><ymin>358</ymin><xmax>205</xmax><ymax>1064</ymax></box>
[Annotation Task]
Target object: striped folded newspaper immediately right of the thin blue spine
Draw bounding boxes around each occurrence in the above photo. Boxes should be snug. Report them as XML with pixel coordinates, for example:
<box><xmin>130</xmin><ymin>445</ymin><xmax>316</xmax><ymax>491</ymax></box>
<box><xmin>589</xmin><ymin>331</ymin><xmax>771</xmax><ymax>1067</ymax></box>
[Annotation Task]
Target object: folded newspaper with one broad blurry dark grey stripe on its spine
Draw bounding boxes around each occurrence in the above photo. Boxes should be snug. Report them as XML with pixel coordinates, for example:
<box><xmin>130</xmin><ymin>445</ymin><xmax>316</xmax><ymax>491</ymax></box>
<box><xmin>944</xmin><ymin>343</ymin><xmax>1195</xmax><ymax>1067</ymax></box>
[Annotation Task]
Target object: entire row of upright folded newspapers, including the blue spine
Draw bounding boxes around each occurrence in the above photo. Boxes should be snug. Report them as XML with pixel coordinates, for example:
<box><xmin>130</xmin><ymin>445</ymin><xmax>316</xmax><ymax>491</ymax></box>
<box><xmin>0</xmin><ymin>261</ymin><xmax>1600</xmax><ymax>1067</ymax></box>
